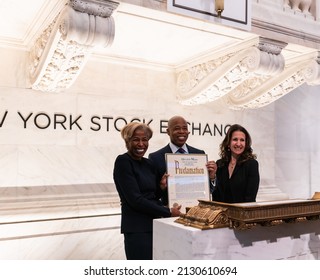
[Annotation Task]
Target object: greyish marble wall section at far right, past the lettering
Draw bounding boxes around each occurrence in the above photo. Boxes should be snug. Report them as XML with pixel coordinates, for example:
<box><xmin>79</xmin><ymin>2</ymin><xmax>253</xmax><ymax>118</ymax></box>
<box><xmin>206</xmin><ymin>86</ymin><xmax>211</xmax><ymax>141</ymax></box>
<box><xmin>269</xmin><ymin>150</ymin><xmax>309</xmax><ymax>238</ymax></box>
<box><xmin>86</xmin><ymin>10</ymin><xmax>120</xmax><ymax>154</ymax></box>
<box><xmin>275</xmin><ymin>85</ymin><xmax>320</xmax><ymax>198</ymax></box>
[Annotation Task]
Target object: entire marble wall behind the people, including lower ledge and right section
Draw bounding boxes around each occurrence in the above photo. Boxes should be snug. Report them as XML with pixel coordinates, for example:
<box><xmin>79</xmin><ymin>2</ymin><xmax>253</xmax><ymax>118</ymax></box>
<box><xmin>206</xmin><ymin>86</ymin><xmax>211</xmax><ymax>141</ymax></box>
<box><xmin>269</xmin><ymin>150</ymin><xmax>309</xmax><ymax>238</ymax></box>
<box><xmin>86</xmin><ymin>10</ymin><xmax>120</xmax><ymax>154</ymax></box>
<box><xmin>0</xmin><ymin>45</ymin><xmax>319</xmax><ymax>259</ymax></box>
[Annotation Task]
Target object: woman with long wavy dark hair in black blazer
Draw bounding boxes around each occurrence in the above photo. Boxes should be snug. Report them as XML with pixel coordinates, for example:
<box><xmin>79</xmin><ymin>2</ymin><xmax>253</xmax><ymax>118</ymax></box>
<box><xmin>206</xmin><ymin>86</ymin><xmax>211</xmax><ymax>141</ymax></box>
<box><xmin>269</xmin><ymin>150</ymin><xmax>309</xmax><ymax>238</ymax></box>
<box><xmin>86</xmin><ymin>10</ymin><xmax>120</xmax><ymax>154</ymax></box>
<box><xmin>212</xmin><ymin>124</ymin><xmax>260</xmax><ymax>203</ymax></box>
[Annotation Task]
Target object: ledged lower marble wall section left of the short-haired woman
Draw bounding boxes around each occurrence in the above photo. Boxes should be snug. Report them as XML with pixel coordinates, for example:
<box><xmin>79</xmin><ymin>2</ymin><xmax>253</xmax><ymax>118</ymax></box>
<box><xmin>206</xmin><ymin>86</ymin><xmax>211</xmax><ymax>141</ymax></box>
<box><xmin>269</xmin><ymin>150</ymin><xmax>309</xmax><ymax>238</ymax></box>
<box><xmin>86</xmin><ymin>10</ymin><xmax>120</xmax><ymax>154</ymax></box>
<box><xmin>0</xmin><ymin>184</ymin><xmax>125</xmax><ymax>260</ymax></box>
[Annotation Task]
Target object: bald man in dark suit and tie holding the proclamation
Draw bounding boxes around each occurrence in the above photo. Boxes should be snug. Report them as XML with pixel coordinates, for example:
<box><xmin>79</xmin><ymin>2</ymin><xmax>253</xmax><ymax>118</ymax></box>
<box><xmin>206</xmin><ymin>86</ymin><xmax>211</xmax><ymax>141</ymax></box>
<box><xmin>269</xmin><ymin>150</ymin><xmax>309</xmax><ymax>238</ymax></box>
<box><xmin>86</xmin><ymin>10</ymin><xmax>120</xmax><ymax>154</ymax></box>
<box><xmin>149</xmin><ymin>116</ymin><xmax>217</xmax><ymax>205</ymax></box>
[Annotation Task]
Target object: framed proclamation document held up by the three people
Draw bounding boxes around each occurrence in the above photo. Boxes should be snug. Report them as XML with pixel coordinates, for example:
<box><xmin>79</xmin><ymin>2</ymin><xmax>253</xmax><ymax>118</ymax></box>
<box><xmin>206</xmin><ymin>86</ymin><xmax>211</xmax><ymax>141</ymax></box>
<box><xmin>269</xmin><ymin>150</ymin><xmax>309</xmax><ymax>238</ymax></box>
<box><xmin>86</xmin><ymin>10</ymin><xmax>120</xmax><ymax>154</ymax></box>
<box><xmin>166</xmin><ymin>154</ymin><xmax>210</xmax><ymax>209</ymax></box>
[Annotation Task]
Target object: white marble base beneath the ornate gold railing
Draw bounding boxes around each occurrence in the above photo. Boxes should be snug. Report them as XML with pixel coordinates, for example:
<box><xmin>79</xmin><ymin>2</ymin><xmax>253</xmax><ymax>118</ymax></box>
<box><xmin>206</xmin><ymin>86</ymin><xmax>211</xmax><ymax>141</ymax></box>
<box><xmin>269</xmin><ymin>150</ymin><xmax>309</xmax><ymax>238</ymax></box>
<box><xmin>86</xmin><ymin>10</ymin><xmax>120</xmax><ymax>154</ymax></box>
<box><xmin>153</xmin><ymin>218</ymin><xmax>320</xmax><ymax>260</ymax></box>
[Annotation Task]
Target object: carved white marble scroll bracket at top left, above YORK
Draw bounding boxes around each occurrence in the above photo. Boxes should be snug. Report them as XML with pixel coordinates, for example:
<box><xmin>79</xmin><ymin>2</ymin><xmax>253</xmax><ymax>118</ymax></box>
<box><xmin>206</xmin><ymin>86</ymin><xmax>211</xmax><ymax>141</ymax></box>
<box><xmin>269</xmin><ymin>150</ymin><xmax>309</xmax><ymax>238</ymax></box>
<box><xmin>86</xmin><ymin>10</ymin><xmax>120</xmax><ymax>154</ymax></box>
<box><xmin>29</xmin><ymin>0</ymin><xmax>119</xmax><ymax>92</ymax></box>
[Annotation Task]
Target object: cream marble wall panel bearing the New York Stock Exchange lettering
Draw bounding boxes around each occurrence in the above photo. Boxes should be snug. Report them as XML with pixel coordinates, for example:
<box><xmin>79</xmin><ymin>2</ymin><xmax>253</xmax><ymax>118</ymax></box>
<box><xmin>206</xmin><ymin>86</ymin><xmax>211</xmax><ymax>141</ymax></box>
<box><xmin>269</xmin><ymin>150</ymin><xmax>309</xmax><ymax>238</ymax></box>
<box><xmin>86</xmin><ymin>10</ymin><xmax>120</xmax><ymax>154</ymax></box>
<box><xmin>0</xmin><ymin>56</ymin><xmax>274</xmax><ymax>187</ymax></box>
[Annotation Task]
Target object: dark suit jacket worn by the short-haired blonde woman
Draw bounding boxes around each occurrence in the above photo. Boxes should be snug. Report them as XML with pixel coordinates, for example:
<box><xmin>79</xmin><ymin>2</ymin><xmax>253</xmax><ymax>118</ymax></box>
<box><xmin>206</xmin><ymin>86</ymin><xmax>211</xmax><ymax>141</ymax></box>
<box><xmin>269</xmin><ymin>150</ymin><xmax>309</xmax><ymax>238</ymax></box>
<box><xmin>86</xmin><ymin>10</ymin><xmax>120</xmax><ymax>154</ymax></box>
<box><xmin>113</xmin><ymin>153</ymin><xmax>171</xmax><ymax>233</ymax></box>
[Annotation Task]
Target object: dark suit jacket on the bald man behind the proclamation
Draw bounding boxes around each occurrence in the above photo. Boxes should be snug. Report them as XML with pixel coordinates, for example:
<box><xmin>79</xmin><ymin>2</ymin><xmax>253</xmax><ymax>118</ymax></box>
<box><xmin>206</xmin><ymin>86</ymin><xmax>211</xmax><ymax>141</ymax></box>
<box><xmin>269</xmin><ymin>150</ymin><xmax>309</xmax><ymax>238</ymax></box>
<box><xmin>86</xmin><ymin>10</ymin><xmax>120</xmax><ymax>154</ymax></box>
<box><xmin>149</xmin><ymin>144</ymin><xmax>205</xmax><ymax>205</ymax></box>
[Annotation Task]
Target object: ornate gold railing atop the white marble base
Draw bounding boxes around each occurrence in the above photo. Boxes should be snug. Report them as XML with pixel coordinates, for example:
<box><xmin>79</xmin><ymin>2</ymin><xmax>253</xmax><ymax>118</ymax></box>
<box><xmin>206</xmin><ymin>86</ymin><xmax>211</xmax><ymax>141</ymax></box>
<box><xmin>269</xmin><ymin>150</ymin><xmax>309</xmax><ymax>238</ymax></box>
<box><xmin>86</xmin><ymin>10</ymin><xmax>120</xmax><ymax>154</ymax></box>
<box><xmin>175</xmin><ymin>193</ymin><xmax>320</xmax><ymax>230</ymax></box>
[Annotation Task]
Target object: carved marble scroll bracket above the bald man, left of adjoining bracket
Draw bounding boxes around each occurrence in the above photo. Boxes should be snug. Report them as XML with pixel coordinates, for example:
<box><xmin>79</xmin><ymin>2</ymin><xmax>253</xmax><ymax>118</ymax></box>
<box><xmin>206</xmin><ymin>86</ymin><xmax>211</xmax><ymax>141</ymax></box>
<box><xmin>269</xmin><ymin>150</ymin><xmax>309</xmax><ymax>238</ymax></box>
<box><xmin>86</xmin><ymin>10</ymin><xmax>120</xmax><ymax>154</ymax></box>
<box><xmin>177</xmin><ymin>37</ymin><xmax>287</xmax><ymax>107</ymax></box>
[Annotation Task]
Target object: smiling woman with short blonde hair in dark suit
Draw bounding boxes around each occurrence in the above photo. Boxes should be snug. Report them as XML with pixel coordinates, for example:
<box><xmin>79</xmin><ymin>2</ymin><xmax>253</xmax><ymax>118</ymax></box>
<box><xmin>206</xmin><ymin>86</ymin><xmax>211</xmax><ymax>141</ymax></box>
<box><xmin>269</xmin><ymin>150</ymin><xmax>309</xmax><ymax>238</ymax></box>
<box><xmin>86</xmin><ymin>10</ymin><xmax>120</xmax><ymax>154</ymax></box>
<box><xmin>113</xmin><ymin>122</ymin><xmax>180</xmax><ymax>260</ymax></box>
